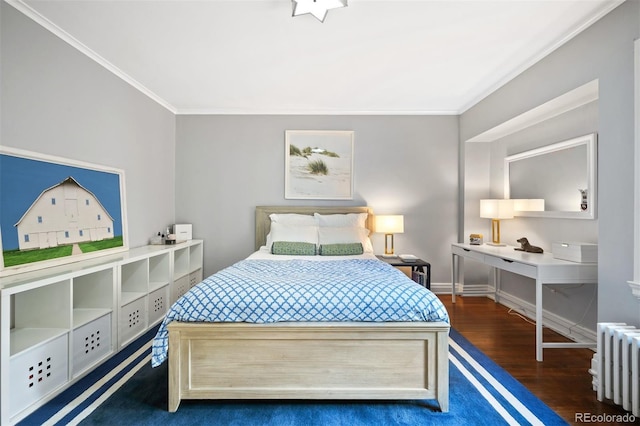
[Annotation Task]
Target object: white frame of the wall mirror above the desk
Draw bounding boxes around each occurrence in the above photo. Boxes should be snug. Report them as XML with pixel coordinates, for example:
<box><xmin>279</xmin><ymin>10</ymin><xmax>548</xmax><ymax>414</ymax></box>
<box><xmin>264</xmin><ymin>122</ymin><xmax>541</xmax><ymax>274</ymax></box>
<box><xmin>504</xmin><ymin>133</ymin><xmax>598</xmax><ymax>219</ymax></box>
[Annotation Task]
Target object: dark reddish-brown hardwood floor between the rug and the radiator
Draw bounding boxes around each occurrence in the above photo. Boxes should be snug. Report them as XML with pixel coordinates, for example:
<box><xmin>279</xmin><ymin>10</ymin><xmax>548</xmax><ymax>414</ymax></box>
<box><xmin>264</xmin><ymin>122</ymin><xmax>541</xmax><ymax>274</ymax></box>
<box><xmin>439</xmin><ymin>295</ymin><xmax>640</xmax><ymax>425</ymax></box>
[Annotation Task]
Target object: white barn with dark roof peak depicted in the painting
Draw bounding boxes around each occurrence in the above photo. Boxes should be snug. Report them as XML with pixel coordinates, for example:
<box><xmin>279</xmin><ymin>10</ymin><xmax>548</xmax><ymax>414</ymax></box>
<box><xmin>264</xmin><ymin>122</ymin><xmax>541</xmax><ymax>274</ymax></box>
<box><xmin>14</xmin><ymin>176</ymin><xmax>113</xmax><ymax>250</ymax></box>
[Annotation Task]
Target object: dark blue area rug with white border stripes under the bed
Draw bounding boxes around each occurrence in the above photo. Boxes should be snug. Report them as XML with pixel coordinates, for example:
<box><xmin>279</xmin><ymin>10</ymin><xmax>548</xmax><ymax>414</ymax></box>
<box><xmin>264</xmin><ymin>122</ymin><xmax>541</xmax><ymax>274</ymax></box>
<box><xmin>20</xmin><ymin>329</ymin><xmax>567</xmax><ymax>426</ymax></box>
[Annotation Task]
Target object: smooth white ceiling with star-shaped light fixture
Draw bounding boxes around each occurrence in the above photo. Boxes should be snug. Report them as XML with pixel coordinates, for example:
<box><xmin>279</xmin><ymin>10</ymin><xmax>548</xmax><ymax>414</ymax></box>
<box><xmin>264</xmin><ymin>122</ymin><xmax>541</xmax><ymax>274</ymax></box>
<box><xmin>7</xmin><ymin>0</ymin><xmax>620</xmax><ymax>114</ymax></box>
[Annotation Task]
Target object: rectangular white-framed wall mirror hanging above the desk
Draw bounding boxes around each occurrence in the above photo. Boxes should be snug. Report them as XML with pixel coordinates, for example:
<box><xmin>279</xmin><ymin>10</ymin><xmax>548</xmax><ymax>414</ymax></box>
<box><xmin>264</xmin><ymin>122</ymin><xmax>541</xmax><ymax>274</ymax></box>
<box><xmin>504</xmin><ymin>133</ymin><xmax>597</xmax><ymax>219</ymax></box>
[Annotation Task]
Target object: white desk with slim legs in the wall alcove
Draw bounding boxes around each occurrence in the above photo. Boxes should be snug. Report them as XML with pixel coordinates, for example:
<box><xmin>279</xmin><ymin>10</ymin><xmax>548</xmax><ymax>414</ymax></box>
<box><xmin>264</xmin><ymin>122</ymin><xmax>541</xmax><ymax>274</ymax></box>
<box><xmin>451</xmin><ymin>243</ymin><xmax>598</xmax><ymax>361</ymax></box>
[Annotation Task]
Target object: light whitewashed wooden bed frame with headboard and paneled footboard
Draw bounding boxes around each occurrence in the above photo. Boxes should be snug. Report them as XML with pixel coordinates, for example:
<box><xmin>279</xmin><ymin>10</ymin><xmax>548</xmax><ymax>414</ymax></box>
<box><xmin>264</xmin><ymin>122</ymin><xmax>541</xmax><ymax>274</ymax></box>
<box><xmin>168</xmin><ymin>206</ymin><xmax>449</xmax><ymax>412</ymax></box>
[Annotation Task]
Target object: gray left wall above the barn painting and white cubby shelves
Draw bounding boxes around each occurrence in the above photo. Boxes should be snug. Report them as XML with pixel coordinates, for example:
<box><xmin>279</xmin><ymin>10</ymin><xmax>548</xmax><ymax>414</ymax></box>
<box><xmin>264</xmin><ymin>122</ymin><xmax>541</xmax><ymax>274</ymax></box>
<box><xmin>0</xmin><ymin>2</ymin><xmax>175</xmax><ymax>247</ymax></box>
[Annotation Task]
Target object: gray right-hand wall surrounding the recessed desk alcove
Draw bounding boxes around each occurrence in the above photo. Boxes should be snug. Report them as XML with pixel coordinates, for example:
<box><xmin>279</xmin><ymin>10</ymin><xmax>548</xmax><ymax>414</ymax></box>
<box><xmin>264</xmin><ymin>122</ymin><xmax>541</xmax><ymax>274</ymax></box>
<box><xmin>460</xmin><ymin>1</ymin><xmax>640</xmax><ymax>325</ymax></box>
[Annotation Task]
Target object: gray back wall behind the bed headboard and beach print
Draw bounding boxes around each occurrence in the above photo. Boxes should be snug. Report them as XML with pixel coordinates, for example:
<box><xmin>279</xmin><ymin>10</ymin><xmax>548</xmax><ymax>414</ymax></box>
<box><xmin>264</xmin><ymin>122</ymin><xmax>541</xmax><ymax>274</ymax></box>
<box><xmin>176</xmin><ymin>116</ymin><xmax>458</xmax><ymax>282</ymax></box>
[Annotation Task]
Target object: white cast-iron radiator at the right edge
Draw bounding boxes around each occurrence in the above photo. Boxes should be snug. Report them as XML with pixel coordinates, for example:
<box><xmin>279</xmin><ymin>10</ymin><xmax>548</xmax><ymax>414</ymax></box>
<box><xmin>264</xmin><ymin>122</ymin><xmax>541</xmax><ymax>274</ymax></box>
<box><xmin>596</xmin><ymin>322</ymin><xmax>640</xmax><ymax>417</ymax></box>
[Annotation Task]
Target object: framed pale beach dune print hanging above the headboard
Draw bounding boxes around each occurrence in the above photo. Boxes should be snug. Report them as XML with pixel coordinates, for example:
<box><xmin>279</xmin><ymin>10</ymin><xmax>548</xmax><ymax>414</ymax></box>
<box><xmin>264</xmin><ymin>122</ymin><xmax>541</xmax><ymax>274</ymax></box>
<box><xmin>284</xmin><ymin>130</ymin><xmax>354</xmax><ymax>200</ymax></box>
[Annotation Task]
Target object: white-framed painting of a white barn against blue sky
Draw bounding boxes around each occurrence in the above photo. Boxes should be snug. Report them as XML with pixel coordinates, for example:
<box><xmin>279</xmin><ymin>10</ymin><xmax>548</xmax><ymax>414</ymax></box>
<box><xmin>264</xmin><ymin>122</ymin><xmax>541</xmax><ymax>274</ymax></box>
<box><xmin>0</xmin><ymin>146</ymin><xmax>128</xmax><ymax>275</ymax></box>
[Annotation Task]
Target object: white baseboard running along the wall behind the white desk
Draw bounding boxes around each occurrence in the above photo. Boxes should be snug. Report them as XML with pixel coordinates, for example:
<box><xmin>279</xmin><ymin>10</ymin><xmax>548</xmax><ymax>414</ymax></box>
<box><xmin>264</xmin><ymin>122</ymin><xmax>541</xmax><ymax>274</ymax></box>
<box><xmin>431</xmin><ymin>283</ymin><xmax>596</xmax><ymax>344</ymax></box>
